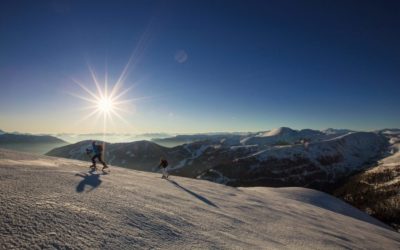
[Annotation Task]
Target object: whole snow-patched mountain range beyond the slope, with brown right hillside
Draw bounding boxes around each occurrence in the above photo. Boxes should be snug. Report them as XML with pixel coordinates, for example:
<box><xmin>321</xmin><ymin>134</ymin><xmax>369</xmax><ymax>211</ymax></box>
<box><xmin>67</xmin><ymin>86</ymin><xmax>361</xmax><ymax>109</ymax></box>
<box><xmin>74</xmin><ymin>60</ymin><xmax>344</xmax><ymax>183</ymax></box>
<box><xmin>10</xmin><ymin>127</ymin><xmax>400</xmax><ymax>228</ymax></box>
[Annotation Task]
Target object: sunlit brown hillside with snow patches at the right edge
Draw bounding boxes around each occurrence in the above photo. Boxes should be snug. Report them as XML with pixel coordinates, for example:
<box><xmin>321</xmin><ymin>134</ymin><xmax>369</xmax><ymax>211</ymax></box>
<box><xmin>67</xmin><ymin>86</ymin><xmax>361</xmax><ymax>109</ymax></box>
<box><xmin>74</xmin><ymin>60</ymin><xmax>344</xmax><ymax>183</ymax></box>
<box><xmin>334</xmin><ymin>129</ymin><xmax>400</xmax><ymax>231</ymax></box>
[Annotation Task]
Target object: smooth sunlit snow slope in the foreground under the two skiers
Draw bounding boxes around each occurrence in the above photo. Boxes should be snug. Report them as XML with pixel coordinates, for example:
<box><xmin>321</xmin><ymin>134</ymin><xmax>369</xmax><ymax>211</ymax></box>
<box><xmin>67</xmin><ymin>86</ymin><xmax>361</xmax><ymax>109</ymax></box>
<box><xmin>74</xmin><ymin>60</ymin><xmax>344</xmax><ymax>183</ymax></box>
<box><xmin>0</xmin><ymin>150</ymin><xmax>400</xmax><ymax>249</ymax></box>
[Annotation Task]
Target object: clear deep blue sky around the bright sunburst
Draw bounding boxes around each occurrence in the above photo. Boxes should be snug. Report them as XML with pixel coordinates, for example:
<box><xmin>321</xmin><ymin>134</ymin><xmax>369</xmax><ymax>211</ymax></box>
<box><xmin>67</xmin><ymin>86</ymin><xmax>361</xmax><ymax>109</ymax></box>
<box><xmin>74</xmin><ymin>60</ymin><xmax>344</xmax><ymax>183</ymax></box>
<box><xmin>0</xmin><ymin>0</ymin><xmax>400</xmax><ymax>133</ymax></box>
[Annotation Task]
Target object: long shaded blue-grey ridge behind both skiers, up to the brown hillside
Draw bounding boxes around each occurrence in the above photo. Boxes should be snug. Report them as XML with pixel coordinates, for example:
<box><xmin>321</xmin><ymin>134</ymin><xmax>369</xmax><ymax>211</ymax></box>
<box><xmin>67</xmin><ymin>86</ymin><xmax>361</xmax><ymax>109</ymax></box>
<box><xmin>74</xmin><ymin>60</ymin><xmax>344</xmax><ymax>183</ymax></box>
<box><xmin>48</xmin><ymin>128</ymin><xmax>394</xmax><ymax>190</ymax></box>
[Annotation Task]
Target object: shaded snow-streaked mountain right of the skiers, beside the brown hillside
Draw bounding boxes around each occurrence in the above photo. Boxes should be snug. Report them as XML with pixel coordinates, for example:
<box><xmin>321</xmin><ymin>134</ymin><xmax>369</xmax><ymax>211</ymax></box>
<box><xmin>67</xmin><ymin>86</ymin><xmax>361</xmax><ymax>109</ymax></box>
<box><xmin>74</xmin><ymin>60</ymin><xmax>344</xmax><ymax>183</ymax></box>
<box><xmin>199</xmin><ymin>132</ymin><xmax>387</xmax><ymax>190</ymax></box>
